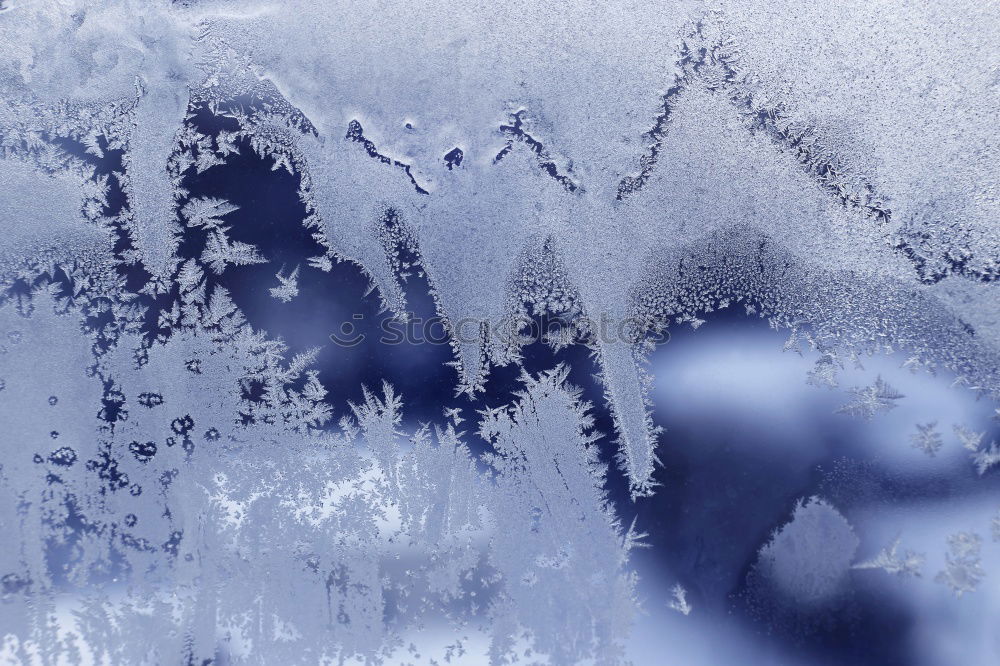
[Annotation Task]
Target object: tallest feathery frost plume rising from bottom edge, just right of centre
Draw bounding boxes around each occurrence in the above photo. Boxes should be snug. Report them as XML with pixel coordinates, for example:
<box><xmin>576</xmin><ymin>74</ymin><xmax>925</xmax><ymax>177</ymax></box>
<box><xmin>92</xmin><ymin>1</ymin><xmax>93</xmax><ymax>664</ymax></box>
<box><xmin>479</xmin><ymin>367</ymin><xmax>635</xmax><ymax>663</ymax></box>
